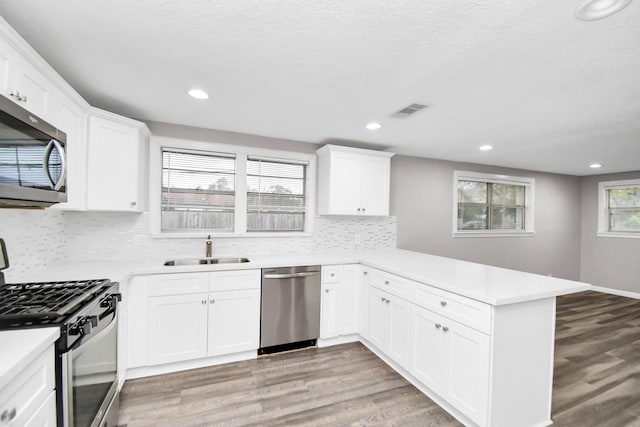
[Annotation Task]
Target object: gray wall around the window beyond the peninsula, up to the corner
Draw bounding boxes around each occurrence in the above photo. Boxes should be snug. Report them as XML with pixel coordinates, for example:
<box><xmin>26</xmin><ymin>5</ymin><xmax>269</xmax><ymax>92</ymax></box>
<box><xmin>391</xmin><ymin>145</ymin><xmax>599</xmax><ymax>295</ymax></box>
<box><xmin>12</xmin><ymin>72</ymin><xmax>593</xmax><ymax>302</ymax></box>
<box><xmin>391</xmin><ymin>156</ymin><xmax>581</xmax><ymax>280</ymax></box>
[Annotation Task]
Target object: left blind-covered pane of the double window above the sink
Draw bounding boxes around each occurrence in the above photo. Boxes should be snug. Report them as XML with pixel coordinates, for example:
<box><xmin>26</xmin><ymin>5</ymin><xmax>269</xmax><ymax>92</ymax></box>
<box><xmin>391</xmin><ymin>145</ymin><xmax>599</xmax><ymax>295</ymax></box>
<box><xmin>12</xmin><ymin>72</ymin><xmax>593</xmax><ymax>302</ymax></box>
<box><xmin>161</xmin><ymin>149</ymin><xmax>235</xmax><ymax>231</ymax></box>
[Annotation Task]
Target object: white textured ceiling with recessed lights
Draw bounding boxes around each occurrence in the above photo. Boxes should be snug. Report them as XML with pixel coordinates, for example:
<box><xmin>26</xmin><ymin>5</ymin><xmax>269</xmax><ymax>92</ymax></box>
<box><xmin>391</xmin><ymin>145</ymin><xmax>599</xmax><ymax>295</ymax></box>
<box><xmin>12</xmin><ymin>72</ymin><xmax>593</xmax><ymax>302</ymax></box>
<box><xmin>0</xmin><ymin>0</ymin><xmax>640</xmax><ymax>175</ymax></box>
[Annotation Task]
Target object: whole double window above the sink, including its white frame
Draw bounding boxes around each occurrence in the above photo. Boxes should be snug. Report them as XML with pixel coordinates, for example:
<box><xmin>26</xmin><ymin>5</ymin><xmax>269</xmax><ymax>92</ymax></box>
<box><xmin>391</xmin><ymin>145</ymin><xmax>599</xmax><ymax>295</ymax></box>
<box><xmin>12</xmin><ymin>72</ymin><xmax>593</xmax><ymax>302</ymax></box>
<box><xmin>149</xmin><ymin>136</ymin><xmax>315</xmax><ymax>238</ymax></box>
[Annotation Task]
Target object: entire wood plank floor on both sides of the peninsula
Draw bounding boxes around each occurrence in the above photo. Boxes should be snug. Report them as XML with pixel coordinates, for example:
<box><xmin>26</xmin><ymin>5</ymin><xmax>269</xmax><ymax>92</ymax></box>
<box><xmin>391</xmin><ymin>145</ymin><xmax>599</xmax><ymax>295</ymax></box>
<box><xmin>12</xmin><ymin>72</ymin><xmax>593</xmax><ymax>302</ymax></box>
<box><xmin>120</xmin><ymin>292</ymin><xmax>640</xmax><ymax>427</ymax></box>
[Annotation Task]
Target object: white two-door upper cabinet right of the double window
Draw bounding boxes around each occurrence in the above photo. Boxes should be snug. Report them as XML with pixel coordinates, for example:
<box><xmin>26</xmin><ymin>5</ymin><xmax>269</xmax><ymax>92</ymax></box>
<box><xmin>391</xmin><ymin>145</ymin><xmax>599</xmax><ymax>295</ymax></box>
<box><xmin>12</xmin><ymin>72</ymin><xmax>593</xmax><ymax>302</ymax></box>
<box><xmin>317</xmin><ymin>145</ymin><xmax>393</xmax><ymax>216</ymax></box>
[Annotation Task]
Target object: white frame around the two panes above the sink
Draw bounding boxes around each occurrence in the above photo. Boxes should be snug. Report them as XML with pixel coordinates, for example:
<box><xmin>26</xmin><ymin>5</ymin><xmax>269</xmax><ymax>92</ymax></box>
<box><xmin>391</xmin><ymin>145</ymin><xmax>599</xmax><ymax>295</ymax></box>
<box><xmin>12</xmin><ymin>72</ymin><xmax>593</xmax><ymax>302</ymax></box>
<box><xmin>149</xmin><ymin>135</ymin><xmax>316</xmax><ymax>239</ymax></box>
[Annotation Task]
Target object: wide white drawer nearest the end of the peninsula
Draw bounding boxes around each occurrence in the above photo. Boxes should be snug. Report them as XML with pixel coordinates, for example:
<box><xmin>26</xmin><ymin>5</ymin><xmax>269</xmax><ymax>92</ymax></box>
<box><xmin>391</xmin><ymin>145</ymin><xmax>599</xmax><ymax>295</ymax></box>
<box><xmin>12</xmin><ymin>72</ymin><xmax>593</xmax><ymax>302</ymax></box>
<box><xmin>415</xmin><ymin>284</ymin><xmax>491</xmax><ymax>334</ymax></box>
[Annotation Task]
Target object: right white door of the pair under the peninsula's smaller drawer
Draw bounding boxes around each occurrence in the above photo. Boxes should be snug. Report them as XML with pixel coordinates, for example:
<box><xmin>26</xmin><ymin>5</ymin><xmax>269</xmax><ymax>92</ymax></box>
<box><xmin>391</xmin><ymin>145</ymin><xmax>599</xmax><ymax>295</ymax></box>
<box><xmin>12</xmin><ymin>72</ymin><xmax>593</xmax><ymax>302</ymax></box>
<box><xmin>385</xmin><ymin>295</ymin><xmax>412</xmax><ymax>369</ymax></box>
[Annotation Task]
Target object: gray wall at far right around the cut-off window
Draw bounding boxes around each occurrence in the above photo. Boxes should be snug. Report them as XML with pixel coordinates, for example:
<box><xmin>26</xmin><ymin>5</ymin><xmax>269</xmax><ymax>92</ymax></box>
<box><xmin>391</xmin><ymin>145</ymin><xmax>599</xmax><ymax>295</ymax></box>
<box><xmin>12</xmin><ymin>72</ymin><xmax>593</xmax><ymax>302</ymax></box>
<box><xmin>580</xmin><ymin>171</ymin><xmax>640</xmax><ymax>293</ymax></box>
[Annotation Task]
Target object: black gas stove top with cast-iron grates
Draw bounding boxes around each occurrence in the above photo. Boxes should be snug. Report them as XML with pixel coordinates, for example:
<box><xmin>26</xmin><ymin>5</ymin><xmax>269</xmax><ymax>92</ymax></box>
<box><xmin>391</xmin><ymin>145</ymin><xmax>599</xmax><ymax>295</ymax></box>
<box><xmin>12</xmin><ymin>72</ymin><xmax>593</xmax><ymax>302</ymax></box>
<box><xmin>0</xmin><ymin>279</ymin><xmax>112</xmax><ymax>329</ymax></box>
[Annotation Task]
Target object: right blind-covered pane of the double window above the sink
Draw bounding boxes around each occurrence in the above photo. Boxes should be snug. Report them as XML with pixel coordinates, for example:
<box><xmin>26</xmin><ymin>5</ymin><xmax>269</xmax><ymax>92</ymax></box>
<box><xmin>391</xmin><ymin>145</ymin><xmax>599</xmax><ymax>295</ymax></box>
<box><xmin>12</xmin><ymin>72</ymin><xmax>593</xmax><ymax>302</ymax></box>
<box><xmin>247</xmin><ymin>158</ymin><xmax>307</xmax><ymax>231</ymax></box>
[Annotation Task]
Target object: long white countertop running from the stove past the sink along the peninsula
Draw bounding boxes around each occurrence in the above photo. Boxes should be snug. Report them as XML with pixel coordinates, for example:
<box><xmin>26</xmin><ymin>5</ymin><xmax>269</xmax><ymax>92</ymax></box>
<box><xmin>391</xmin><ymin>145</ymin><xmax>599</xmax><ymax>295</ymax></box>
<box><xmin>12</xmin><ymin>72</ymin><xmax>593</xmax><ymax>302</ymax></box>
<box><xmin>15</xmin><ymin>249</ymin><xmax>590</xmax><ymax>305</ymax></box>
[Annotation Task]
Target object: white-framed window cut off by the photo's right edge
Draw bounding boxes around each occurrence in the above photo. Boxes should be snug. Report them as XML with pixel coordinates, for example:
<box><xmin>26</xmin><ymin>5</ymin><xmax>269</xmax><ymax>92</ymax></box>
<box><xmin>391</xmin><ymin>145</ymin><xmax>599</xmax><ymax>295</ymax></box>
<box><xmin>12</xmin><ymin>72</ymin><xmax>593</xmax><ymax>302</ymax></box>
<box><xmin>598</xmin><ymin>179</ymin><xmax>640</xmax><ymax>237</ymax></box>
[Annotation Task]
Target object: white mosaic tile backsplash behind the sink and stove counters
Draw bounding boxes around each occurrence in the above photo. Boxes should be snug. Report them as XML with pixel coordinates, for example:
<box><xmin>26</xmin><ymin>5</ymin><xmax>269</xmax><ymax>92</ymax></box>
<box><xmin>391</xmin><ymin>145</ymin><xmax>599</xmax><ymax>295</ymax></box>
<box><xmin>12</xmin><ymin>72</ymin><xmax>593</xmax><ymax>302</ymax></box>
<box><xmin>0</xmin><ymin>209</ymin><xmax>396</xmax><ymax>281</ymax></box>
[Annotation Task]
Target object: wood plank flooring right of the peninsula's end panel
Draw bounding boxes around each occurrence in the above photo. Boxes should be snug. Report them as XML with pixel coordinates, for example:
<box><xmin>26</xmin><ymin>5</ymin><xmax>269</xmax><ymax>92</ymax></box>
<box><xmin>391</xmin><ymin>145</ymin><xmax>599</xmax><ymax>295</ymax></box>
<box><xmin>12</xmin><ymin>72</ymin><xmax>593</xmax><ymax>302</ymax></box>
<box><xmin>551</xmin><ymin>291</ymin><xmax>640</xmax><ymax>427</ymax></box>
